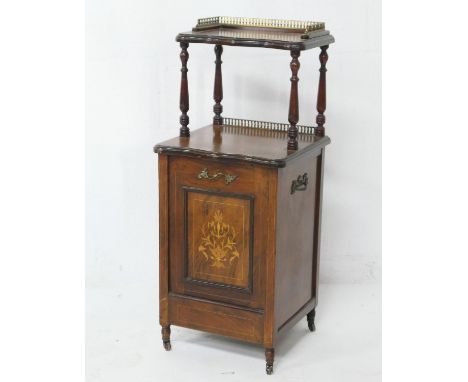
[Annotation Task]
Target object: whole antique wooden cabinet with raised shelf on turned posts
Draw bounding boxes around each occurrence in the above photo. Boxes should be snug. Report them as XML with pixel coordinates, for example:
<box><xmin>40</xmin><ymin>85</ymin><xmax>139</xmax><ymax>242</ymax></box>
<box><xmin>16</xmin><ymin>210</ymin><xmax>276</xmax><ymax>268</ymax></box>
<box><xmin>155</xmin><ymin>17</ymin><xmax>334</xmax><ymax>374</ymax></box>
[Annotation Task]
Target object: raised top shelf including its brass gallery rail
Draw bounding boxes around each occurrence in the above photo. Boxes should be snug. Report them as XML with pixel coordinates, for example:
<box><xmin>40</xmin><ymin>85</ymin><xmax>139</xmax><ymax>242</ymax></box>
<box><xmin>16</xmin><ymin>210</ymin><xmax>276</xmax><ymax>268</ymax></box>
<box><xmin>176</xmin><ymin>16</ymin><xmax>335</xmax><ymax>50</ymax></box>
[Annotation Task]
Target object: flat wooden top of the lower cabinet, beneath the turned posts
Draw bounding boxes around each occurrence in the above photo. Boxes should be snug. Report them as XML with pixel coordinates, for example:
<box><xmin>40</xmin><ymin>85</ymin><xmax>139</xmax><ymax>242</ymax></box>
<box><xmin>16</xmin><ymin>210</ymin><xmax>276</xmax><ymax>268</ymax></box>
<box><xmin>154</xmin><ymin>125</ymin><xmax>330</xmax><ymax>167</ymax></box>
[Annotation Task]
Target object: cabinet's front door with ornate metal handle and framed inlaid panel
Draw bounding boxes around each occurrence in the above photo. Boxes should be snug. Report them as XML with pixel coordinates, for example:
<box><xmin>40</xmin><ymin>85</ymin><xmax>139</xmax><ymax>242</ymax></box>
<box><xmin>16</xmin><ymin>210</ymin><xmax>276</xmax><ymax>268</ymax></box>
<box><xmin>169</xmin><ymin>157</ymin><xmax>272</xmax><ymax>309</ymax></box>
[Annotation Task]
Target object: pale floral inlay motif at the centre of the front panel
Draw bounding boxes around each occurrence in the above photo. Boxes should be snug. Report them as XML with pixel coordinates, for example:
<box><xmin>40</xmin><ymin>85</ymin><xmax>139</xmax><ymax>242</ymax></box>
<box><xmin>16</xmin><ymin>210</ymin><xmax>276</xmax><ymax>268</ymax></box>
<box><xmin>198</xmin><ymin>210</ymin><xmax>240</xmax><ymax>268</ymax></box>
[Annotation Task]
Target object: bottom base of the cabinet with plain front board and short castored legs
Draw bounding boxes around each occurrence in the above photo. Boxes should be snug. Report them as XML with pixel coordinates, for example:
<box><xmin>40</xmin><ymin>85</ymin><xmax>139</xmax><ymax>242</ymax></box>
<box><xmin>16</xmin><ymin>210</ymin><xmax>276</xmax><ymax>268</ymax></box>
<box><xmin>161</xmin><ymin>294</ymin><xmax>315</xmax><ymax>374</ymax></box>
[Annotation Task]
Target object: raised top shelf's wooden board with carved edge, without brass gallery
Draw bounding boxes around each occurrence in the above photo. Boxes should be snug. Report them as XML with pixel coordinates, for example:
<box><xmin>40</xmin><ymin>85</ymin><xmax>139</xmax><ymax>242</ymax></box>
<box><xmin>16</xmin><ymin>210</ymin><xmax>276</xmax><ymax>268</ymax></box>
<box><xmin>176</xmin><ymin>27</ymin><xmax>335</xmax><ymax>50</ymax></box>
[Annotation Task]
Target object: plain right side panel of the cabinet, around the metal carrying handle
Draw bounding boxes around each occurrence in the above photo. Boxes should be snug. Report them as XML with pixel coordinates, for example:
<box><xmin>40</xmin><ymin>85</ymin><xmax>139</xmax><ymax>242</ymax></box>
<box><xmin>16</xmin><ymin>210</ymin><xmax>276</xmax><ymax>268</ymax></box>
<box><xmin>275</xmin><ymin>154</ymin><xmax>317</xmax><ymax>330</ymax></box>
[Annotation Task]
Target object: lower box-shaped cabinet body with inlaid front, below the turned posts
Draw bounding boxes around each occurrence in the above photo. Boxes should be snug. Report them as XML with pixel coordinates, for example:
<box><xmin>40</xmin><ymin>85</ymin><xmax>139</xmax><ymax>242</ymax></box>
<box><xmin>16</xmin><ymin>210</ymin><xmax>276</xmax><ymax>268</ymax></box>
<box><xmin>158</xmin><ymin>139</ymin><xmax>329</xmax><ymax>374</ymax></box>
